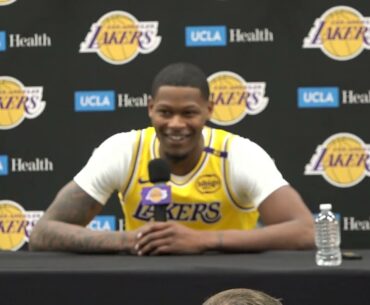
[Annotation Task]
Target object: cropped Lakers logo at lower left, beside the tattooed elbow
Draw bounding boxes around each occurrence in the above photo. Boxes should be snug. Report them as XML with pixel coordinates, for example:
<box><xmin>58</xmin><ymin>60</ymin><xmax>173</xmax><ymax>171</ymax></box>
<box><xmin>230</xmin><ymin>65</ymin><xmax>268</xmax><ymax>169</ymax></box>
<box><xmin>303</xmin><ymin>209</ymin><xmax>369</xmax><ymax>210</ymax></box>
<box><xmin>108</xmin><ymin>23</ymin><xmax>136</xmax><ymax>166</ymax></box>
<box><xmin>0</xmin><ymin>200</ymin><xmax>43</xmax><ymax>251</ymax></box>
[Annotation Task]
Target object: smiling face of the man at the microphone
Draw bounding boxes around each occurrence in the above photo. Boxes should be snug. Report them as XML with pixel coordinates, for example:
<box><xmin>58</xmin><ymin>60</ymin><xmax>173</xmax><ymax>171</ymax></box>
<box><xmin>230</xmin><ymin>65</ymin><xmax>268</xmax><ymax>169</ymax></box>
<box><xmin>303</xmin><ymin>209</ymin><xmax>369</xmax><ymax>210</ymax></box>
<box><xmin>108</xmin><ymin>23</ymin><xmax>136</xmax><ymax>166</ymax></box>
<box><xmin>149</xmin><ymin>86</ymin><xmax>212</xmax><ymax>160</ymax></box>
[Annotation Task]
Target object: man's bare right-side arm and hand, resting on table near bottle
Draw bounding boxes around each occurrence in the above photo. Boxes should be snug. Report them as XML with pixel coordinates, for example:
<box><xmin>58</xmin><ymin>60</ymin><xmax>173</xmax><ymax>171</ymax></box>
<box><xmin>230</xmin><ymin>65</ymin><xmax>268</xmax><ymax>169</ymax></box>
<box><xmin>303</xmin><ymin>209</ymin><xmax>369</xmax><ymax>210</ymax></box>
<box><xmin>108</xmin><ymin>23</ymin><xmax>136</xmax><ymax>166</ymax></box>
<box><xmin>136</xmin><ymin>186</ymin><xmax>314</xmax><ymax>255</ymax></box>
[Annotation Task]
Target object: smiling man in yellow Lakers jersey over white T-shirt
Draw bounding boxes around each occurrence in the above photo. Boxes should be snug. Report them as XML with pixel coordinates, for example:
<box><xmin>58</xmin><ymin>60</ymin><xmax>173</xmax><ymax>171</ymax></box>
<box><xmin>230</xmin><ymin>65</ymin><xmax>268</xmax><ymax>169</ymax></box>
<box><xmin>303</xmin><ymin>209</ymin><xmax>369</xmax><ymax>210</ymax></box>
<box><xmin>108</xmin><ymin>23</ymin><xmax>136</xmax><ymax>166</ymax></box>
<box><xmin>30</xmin><ymin>63</ymin><xmax>314</xmax><ymax>255</ymax></box>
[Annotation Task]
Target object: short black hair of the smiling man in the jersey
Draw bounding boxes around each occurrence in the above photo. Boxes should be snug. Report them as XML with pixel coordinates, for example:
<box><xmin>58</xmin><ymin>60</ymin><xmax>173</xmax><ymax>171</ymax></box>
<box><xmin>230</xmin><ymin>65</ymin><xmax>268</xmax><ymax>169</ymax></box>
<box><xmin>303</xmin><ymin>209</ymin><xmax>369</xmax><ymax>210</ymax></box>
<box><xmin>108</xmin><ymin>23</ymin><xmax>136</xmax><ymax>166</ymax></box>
<box><xmin>152</xmin><ymin>62</ymin><xmax>209</xmax><ymax>100</ymax></box>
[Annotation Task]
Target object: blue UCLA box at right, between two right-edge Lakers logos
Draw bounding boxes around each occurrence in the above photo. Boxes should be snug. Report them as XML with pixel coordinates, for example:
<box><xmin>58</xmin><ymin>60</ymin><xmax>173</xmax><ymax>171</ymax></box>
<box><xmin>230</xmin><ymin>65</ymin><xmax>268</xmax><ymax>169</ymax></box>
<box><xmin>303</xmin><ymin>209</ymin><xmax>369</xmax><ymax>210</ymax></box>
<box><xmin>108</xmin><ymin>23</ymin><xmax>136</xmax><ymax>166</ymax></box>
<box><xmin>297</xmin><ymin>87</ymin><xmax>339</xmax><ymax>108</ymax></box>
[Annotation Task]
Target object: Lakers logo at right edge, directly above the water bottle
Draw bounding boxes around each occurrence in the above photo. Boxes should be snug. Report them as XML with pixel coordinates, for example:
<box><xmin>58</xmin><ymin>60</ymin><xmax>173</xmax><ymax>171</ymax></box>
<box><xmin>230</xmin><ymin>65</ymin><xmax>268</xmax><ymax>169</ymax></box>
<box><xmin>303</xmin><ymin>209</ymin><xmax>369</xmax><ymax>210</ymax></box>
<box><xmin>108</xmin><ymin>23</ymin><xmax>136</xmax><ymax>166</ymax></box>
<box><xmin>305</xmin><ymin>133</ymin><xmax>370</xmax><ymax>188</ymax></box>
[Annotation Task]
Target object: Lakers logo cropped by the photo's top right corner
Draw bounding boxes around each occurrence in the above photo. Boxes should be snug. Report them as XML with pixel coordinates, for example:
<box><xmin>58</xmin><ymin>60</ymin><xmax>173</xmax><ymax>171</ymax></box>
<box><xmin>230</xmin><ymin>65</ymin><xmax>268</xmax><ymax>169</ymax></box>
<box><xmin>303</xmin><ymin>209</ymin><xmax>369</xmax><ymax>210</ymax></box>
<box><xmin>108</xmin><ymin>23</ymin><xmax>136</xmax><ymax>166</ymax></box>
<box><xmin>303</xmin><ymin>6</ymin><xmax>370</xmax><ymax>60</ymax></box>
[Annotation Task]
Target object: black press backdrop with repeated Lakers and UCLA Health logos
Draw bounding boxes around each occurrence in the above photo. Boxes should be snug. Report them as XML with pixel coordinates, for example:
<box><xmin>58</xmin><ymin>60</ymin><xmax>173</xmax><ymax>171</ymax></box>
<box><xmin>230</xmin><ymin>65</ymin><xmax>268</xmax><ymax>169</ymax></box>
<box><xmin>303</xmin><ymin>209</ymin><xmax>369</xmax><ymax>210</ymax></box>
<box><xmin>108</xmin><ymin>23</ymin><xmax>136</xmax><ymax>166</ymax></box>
<box><xmin>0</xmin><ymin>0</ymin><xmax>370</xmax><ymax>250</ymax></box>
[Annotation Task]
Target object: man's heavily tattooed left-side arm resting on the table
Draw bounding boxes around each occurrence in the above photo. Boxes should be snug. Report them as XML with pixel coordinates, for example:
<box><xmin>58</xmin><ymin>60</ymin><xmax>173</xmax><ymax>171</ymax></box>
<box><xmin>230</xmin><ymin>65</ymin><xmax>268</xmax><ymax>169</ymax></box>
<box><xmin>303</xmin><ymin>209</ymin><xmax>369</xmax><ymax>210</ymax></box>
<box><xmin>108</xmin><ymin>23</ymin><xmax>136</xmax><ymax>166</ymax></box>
<box><xmin>30</xmin><ymin>181</ymin><xmax>135</xmax><ymax>253</ymax></box>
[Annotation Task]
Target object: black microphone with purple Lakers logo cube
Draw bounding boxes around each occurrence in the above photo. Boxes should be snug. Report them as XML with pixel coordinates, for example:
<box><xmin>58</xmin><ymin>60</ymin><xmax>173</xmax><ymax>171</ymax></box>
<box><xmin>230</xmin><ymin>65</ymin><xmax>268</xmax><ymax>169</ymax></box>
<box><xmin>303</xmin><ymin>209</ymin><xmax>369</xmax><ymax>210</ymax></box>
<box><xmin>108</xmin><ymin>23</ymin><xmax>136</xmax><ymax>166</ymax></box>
<box><xmin>142</xmin><ymin>159</ymin><xmax>171</xmax><ymax>221</ymax></box>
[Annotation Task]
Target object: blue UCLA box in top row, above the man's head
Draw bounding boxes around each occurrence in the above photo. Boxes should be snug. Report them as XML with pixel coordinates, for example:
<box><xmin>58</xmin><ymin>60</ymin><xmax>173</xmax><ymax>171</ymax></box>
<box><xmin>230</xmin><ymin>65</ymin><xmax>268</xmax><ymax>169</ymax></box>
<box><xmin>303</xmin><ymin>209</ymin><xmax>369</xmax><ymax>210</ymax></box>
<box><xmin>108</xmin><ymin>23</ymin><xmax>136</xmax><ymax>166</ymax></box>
<box><xmin>185</xmin><ymin>25</ymin><xmax>227</xmax><ymax>47</ymax></box>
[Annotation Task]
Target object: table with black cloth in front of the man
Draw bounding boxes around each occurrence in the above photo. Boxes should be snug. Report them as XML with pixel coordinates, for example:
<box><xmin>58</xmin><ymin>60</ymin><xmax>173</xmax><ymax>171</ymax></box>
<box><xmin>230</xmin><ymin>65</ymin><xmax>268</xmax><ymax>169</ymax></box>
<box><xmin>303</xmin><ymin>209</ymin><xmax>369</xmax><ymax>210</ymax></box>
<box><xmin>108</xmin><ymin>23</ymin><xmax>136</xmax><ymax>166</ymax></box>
<box><xmin>0</xmin><ymin>250</ymin><xmax>370</xmax><ymax>305</ymax></box>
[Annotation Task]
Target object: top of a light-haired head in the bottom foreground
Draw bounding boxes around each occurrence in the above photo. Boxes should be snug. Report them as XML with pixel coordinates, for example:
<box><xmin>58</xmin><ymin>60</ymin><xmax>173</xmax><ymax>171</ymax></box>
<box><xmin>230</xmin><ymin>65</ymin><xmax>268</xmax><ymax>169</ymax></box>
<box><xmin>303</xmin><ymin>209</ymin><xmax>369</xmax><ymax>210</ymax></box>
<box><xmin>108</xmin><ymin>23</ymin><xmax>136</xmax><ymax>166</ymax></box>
<box><xmin>203</xmin><ymin>288</ymin><xmax>282</xmax><ymax>305</ymax></box>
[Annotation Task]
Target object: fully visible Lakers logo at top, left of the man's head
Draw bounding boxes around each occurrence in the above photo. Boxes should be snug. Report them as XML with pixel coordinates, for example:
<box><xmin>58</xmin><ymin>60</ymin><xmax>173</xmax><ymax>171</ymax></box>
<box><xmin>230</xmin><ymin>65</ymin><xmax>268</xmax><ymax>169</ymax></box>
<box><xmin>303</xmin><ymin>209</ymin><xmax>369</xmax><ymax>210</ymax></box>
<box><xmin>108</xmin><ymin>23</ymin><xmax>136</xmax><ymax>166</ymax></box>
<box><xmin>80</xmin><ymin>11</ymin><xmax>161</xmax><ymax>65</ymax></box>
